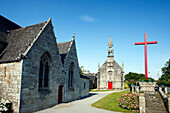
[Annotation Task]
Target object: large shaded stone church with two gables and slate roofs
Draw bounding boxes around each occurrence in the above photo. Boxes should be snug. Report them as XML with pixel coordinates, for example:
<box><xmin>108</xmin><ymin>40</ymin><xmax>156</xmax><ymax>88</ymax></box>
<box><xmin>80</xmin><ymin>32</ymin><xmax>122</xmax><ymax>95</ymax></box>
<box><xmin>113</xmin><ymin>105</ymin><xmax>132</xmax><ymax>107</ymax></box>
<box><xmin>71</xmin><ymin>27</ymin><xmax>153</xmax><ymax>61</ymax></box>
<box><xmin>0</xmin><ymin>15</ymin><xmax>89</xmax><ymax>113</ymax></box>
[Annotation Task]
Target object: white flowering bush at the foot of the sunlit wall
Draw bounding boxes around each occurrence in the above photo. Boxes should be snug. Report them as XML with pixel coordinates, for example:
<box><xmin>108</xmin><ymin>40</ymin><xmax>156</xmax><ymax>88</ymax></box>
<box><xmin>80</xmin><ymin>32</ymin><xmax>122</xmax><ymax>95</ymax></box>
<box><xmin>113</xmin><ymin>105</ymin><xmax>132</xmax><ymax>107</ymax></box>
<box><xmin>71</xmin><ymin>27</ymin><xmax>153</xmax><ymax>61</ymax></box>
<box><xmin>0</xmin><ymin>98</ymin><xmax>12</xmax><ymax>113</ymax></box>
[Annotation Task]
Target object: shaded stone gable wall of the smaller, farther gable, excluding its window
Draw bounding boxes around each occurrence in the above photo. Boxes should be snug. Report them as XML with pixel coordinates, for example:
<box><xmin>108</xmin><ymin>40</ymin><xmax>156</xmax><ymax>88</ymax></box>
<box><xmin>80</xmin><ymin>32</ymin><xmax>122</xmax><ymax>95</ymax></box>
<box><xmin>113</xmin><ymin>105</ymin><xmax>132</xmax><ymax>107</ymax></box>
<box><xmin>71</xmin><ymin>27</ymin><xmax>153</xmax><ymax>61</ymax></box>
<box><xmin>64</xmin><ymin>39</ymin><xmax>81</xmax><ymax>102</ymax></box>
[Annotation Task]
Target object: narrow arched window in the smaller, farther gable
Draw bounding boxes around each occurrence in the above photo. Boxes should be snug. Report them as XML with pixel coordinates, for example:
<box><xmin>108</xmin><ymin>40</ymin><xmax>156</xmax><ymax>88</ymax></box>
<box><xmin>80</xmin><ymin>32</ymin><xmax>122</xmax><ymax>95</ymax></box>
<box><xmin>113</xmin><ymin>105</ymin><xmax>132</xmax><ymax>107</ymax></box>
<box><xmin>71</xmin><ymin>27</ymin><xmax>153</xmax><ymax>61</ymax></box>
<box><xmin>68</xmin><ymin>62</ymin><xmax>74</xmax><ymax>87</ymax></box>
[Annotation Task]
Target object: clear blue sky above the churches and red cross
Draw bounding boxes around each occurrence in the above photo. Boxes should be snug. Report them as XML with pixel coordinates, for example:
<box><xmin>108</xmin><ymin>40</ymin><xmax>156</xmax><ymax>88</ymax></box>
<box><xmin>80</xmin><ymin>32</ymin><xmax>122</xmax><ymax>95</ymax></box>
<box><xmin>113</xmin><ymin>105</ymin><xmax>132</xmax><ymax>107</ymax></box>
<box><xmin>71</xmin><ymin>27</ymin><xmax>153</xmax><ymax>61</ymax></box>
<box><xmin>0</xmin><ymin>0</ymin><xmax>170</xmax><ymax>79</ymax></box>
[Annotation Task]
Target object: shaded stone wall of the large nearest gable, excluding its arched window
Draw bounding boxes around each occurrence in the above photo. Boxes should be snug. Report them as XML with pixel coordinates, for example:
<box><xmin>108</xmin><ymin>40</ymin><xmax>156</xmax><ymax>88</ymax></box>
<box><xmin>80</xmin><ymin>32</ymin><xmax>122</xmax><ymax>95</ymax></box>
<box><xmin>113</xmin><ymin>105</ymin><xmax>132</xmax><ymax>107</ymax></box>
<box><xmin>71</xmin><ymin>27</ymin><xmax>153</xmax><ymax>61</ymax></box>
<box><xmin>20</xmin><ymin>21</ymin><xmax>65</xmax><ymax>112</ymax></box>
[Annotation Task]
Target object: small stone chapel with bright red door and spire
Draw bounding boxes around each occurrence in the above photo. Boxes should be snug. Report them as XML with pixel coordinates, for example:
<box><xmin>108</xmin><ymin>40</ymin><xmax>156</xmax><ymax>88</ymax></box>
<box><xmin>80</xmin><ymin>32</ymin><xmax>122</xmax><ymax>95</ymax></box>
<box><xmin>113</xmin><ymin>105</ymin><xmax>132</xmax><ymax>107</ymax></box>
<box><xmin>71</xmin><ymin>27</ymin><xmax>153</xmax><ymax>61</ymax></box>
<box><xmin>97</xmin><ymin>36</ymin><xmax>124</xmax><ymax>89</ymax></box>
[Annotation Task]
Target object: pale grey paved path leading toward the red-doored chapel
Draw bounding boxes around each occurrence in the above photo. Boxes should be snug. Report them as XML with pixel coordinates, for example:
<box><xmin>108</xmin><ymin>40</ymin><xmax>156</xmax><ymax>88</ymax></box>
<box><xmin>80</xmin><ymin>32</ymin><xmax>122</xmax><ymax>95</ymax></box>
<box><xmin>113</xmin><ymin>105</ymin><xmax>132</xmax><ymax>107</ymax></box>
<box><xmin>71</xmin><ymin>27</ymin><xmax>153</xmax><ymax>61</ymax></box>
<box><xmin>36</xmin><ymin>91</ymin><xmax>125</xmax><ymax>113</ymax></box>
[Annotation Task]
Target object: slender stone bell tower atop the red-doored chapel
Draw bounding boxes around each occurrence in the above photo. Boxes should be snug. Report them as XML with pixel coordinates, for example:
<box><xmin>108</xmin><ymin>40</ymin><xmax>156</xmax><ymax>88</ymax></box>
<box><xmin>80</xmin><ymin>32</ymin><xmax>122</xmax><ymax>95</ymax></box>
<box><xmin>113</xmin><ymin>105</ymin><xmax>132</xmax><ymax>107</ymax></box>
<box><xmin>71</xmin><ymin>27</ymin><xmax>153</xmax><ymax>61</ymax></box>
<box><xmin>107</xmin><ymin>36</ymin><xmax>114</xmax><ymax>62</ymax></box>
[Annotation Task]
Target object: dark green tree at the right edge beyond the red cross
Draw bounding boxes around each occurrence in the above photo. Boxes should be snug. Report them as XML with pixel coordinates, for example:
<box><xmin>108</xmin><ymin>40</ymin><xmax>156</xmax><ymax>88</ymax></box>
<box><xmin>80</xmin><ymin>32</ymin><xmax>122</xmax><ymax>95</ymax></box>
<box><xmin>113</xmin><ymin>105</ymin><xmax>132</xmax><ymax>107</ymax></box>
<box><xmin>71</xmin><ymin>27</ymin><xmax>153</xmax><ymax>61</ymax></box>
<box><xmin>157</xmin><ymin>59</ymin><xmax>170</xmax><ymax>86</ymax></box>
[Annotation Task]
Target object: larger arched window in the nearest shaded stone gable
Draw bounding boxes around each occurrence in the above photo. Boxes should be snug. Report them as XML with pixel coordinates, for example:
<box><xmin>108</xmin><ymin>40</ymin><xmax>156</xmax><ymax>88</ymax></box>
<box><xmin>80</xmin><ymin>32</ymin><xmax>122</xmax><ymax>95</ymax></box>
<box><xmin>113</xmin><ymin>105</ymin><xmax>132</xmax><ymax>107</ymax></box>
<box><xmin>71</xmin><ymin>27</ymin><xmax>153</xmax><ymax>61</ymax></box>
<box><xmin>38</xmin><ymin>52</ymin><xmax>50</xmax><ymax>90</ymax></box>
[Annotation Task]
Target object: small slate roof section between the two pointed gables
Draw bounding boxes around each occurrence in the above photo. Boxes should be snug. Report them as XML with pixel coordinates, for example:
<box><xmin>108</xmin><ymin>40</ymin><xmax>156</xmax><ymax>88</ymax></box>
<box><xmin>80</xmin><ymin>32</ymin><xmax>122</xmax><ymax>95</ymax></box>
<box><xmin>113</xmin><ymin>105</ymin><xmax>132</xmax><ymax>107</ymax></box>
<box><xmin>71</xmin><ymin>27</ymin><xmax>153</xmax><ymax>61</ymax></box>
<box><xmin>57</xmin><ymin>41</ymin><xmax>71</xmax><ymax>64</ymax></box>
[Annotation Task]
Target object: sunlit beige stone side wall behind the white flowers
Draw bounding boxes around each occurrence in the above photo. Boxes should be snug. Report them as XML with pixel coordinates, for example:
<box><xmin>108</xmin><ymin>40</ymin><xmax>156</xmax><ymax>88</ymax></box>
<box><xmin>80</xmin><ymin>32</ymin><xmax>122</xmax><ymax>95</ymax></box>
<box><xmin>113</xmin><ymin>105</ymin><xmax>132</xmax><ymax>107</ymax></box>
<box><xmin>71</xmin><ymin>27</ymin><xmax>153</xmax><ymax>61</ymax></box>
<box><xmin>0</xmin><ymin>61</ymin><xmax>22</xmax><ymax>113</ymax></box>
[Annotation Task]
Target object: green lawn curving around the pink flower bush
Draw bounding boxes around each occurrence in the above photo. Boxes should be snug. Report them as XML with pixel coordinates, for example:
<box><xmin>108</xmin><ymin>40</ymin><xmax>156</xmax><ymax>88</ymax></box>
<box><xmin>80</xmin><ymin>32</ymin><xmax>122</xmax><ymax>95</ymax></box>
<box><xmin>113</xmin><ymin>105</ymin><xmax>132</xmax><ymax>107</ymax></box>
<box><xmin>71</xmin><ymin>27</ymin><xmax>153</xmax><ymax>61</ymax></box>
<box><xmin>92</xmin><ymin>91</ymin><xmax>134</xmax><ymax>113</ymax></box>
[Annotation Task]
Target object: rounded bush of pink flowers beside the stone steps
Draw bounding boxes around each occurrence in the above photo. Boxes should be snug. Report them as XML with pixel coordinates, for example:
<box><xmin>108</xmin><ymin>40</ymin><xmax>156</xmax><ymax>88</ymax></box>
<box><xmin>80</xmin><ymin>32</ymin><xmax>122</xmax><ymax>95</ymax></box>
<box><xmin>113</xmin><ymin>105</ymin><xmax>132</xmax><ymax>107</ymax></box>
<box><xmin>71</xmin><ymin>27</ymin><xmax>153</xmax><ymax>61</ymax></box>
<box><xmin>118</xmin><ymin>92</ymin><xmax>139</xmax><ymax>112</ymax></box>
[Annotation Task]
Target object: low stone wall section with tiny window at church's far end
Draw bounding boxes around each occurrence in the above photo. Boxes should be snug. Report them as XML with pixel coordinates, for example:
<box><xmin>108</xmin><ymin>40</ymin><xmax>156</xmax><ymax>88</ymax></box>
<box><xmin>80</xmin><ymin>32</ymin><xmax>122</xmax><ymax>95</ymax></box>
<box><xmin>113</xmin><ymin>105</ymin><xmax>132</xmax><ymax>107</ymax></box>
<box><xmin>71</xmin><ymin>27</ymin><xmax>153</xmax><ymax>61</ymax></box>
<box><xmin>80</xmin><ymin>78</ymin><xmax>89</xmax><ymax>97</ymax></box>
